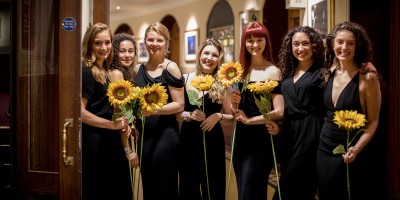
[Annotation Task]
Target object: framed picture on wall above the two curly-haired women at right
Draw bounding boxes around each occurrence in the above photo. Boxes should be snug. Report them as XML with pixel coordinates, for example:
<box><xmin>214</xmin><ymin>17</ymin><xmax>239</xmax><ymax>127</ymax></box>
<box><xmin>307</xmin><ymin>0</ymin><xmax>333</xmax><ymax>38</ymax></box>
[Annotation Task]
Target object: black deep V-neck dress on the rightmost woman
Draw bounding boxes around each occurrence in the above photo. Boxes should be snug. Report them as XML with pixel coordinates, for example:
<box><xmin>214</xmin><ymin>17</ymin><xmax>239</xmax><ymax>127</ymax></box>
<box><xmin>317</xmin><ymin>73</ymin><xmax>372</xmax><ymax>200</ymax></box>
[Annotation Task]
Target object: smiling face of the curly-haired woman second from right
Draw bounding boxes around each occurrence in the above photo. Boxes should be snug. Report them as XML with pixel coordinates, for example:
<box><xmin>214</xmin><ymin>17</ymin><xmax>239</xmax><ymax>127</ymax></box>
<box><xmin>292</xmin><ymin>32</ymin><xmax>313</xmax><ymax>62</ymax></box>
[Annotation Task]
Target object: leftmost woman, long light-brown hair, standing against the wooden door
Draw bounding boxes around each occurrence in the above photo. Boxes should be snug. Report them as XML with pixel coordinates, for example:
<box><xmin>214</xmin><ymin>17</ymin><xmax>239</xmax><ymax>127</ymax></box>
<box><xmin>81</xmin><ymin>23</ymin><xmax>132</xmax><ymax>199</ymax></box>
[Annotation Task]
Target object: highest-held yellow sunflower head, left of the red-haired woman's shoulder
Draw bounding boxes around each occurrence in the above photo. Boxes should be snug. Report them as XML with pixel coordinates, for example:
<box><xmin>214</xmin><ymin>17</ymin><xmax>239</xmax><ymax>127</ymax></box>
<box><xmin>218</xmin><ymin>61</ymin><xmax>243</xmax><ymax>86</ymax></box>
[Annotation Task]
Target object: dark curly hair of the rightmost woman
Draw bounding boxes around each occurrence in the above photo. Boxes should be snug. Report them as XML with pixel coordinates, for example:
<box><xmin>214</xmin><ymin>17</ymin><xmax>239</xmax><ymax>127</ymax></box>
<box><xmin>325</xmin><ymin>22</ymin><xmax>372</xmax><ymax>68</ymax></box>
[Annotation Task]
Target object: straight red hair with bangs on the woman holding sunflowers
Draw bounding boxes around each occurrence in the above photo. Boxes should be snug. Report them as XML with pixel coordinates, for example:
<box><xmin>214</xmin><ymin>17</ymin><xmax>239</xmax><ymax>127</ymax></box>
<box><xmin>239</xmin><ymin>22</ymin><xmax>274</xmax><ymax>77</ymax></box>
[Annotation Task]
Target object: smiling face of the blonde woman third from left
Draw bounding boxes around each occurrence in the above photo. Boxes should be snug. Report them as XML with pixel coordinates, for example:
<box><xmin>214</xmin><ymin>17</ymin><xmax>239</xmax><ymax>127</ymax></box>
<box><xmin>146</xmin><ymin>31</ymin><xmax>167</xmax><ymax>56</ymax></box>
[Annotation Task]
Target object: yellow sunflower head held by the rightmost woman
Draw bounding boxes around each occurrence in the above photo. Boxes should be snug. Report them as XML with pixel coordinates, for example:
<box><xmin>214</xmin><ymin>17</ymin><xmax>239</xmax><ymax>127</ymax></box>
<box><xmin>333</xmin><ymin>110</ymin><xmax>367</xmax><ymax>130</ymax></box>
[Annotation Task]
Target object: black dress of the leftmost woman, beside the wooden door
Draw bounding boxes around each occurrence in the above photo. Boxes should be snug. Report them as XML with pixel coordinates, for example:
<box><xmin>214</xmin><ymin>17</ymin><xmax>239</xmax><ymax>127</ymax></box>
<box><xmin>82</xmin><ymin>66</ymin><xmax>132</xmax><ymax>200</ymax></box>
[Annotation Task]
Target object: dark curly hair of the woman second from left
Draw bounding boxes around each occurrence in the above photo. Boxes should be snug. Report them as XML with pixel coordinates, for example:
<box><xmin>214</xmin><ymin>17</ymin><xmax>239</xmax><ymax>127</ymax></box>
<box><xmin>110</xmin><ymin>33</ymin><xmax>138</xmax><ymax>80</ymax></box>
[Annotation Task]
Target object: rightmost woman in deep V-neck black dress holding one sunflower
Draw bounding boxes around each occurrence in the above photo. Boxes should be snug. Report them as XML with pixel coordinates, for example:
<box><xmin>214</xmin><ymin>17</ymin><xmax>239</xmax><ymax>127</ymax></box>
<box><xmin>317</xmin><ymin>22</ymin><xmax>381</xmax><ymax>200</ymax></box>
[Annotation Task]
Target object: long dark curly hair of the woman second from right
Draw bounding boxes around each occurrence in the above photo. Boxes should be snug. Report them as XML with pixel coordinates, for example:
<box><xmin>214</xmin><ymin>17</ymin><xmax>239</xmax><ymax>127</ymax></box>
<box><xmin>277</xmin><ymin>26</ymin><xmax>325</xmax><ymax>80</ymax></box>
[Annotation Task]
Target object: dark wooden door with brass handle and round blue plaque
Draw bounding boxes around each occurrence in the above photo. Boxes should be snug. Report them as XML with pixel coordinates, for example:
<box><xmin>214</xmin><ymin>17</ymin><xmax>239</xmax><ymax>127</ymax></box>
<box><xmin>12</xmin><ymin>0</ymin><xmax>81</xmax><ymax>200</ymax></box>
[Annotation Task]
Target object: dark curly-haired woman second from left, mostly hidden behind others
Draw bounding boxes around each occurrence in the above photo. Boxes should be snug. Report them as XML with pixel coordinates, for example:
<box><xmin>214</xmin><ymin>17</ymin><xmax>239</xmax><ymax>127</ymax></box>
<box><xmin>108</xmin><ymin>33</ymin><xmax>139</xmax><ymax>168</ymax></box>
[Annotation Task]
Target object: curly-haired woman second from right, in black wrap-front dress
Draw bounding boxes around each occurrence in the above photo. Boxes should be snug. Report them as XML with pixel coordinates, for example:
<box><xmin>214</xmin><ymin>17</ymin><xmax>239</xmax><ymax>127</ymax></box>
<box><xmin>267</xmin><ymin>26</ymin><xmax>325</xmax><ymax>200</ymax></box>
